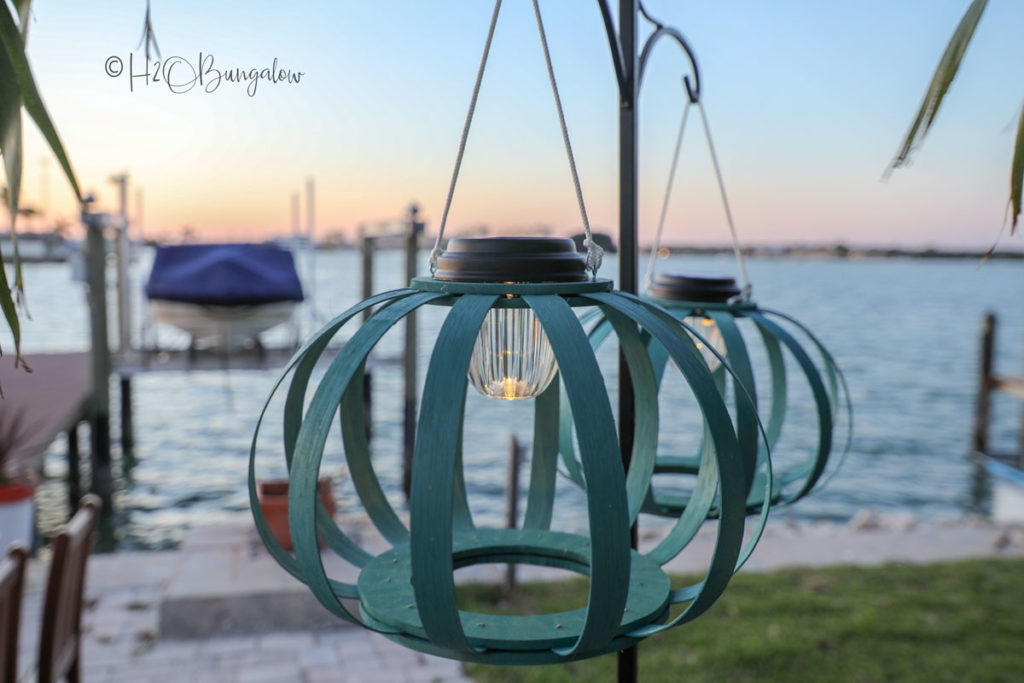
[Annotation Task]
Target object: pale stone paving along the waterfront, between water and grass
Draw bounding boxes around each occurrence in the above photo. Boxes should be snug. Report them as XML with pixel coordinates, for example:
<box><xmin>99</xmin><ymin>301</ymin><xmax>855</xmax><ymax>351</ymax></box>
<box><xmin>19</xmin><ymin>513</ymin><xmax>1024</xmax><ymax>683</ymax></box>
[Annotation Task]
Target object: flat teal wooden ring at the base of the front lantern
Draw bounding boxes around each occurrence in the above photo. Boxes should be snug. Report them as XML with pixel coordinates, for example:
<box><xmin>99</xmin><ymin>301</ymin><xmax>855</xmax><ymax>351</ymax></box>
<box><xmin>358</xmin><ymin>529</ymin><xmax>672</xmax><ymax>664</ymax></box>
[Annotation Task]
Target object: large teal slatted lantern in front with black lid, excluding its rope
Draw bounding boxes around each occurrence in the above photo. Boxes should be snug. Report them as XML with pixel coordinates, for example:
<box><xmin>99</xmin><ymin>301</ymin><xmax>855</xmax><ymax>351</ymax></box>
<box><xmin>243</xmin><ymin>239</ymin><xmax>758</xmax><ymax>664</ymax></box>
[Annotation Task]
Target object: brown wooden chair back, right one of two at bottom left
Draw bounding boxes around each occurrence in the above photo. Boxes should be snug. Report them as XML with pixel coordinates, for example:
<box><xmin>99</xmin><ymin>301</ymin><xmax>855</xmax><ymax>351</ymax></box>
<box><xmin>39</xmin><ymin>494</ymin><xmax>101</xmax><ymax>683</ymax></box>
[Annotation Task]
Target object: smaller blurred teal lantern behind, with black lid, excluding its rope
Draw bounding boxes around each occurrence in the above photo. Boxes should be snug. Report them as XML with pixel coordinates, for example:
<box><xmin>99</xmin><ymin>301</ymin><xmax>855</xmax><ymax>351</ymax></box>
<box><xmin>630</xmin><ymin>274</ymin><xmax>852</xmax><ymax>516</ymax></box>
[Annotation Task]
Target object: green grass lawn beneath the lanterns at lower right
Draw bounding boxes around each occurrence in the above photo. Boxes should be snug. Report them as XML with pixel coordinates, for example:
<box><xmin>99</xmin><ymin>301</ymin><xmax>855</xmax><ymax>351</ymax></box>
<box><xmin>460</xmin><ymin>559</ymin><xmax>1024</xmax><ymax>683</ymax></box>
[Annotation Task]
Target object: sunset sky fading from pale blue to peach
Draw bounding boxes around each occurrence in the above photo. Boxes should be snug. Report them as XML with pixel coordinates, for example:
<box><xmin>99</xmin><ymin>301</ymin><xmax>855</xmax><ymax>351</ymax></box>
<box><xmin>14</xmin><ymin>0</ymin><xmax>1024</xmax><ymax>249</ymax></box>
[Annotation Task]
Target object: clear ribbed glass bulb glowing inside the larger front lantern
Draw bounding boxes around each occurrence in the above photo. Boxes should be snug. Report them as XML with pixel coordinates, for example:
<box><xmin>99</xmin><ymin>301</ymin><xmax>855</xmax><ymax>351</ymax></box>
<box><xmin>468</xmin><ymin>308</ymin><xmax>558</xmax><ymax>400</ymax></box>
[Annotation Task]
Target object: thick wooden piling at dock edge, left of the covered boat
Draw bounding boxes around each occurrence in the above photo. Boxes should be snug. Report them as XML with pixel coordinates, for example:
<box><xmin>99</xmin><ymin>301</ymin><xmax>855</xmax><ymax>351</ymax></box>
<box><xmin>84</xmin><ymin>214</ymin><xmax>113</xmax><ymax>502</ymax></box>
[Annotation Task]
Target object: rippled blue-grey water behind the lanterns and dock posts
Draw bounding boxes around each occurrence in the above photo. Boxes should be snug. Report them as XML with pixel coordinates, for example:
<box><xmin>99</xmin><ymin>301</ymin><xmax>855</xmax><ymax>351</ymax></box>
<box><xmin>8</xmin><ymin>252</ymin><xmax>1024</xmax><ymax>549</ymax></box>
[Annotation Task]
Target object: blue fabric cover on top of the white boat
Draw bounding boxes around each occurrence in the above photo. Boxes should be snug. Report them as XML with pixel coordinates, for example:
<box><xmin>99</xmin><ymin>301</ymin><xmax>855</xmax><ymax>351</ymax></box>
<box><xmin>145</xmin><ymin>244</ymin><xmax>303</xmax><ymax>306</ymax></box>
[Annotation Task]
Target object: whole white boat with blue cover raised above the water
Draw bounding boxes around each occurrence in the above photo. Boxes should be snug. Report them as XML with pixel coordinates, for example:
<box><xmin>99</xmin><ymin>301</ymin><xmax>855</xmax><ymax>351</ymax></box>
<box><xmin>145</xmin><ymin>243</ymin><xmax>304</xmax><ymax>348</ymax></box>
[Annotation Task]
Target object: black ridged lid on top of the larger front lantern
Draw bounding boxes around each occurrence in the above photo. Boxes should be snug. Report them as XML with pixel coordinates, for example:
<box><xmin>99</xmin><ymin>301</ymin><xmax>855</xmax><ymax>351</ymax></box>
<box><xmin>434</xmin><ymin>238</ymin><xmax>587</xmax><ymax>283</ymax></box>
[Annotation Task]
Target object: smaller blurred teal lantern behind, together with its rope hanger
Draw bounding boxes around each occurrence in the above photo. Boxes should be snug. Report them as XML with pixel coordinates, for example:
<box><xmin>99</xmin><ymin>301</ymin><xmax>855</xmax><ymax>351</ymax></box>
<box><xmin>610</xmin><ymin>66</ymin><xmax>853</xmax><ymax>517</ymax></box>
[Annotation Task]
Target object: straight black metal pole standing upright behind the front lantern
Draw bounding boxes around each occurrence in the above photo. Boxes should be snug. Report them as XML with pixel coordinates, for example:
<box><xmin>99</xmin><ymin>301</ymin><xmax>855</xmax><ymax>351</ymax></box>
<box><xmin>618</xmin><ymin>0</ymin><xmax>639</xmax><ymax>683</ymax></box>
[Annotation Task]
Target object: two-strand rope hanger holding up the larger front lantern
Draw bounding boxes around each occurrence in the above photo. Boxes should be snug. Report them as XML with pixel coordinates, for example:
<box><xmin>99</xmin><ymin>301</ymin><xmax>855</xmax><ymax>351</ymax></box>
<box><xmin>430</xmin><ymin>0</ymin><xmax>604</xmax><ymax>279</ymax></box>
